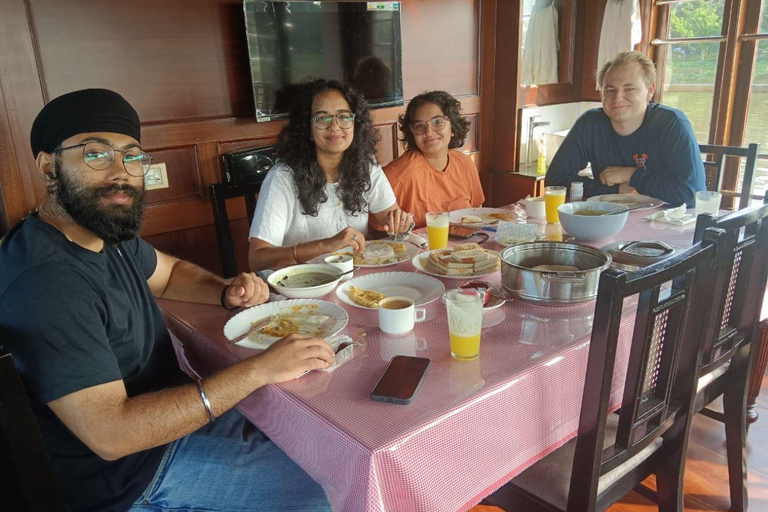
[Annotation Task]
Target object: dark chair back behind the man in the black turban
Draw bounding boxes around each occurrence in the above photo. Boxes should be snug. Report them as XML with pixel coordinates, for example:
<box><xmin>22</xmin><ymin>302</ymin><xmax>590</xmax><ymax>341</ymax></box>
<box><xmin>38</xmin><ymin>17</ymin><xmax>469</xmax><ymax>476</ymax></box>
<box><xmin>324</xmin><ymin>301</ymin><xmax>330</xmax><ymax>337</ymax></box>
<box><xmin>0</xmin><ymin>347</ymin><xmax>66</xmax><ymax>512</ymax></box>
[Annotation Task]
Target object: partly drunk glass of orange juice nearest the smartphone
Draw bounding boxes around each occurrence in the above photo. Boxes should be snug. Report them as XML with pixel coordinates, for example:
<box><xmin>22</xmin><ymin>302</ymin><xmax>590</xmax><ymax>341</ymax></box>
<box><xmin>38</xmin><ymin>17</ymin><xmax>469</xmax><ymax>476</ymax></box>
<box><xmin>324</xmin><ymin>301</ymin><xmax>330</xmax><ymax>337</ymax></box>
<box><xmin>445</xmin><ymin>288</ymin><xmax>483</xmax><ymax>361</ymax></box>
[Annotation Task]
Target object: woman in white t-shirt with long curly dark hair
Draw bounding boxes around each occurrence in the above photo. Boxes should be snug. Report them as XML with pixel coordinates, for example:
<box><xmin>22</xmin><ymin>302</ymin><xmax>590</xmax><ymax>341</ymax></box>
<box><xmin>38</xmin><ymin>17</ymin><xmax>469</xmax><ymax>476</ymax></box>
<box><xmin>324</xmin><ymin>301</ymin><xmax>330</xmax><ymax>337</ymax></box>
<box><xmin>248</xmin><ymin>79</ymin><xmax>411</xmax><ymax>271</ymax></box>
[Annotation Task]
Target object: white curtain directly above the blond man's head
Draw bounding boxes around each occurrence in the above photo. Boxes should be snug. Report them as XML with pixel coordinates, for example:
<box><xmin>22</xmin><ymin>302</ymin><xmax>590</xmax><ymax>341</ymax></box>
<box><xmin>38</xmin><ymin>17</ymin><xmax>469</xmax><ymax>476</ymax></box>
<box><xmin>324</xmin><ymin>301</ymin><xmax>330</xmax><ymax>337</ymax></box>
<box><xmin>597</xmin><ymin>0</ymin><xmax>643</xmax><ymax>83</ymax></box>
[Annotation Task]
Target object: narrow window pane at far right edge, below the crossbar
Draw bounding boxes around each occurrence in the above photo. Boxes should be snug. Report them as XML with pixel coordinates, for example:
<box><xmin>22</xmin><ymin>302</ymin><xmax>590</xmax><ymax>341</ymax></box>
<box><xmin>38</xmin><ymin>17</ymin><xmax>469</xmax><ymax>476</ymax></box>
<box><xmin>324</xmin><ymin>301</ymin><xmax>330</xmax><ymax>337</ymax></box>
<box><xmin>744</xmin><ymin>39</ymin><xmax>768</xmax><ymax>202</ymax></box>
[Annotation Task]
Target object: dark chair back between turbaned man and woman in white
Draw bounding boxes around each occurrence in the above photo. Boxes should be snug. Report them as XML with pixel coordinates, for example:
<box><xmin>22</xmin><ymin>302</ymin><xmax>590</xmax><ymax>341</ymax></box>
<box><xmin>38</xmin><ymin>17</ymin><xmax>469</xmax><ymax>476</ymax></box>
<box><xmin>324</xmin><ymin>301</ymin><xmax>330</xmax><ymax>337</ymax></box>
<box><xmin>210</xmin><ymin>183</ymin><xmax>261</xmax><ymax>278</ymax></box>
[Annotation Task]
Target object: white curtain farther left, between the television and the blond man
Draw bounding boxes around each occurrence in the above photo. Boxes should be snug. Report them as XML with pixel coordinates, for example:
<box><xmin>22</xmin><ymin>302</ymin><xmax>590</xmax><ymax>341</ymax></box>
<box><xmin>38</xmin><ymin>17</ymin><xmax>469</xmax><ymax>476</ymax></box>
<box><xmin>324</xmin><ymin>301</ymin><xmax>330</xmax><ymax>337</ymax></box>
<box><xmin>521</xmin><ymin>0</ymin><xmax>560</xmax><ymax>85</ymax></box>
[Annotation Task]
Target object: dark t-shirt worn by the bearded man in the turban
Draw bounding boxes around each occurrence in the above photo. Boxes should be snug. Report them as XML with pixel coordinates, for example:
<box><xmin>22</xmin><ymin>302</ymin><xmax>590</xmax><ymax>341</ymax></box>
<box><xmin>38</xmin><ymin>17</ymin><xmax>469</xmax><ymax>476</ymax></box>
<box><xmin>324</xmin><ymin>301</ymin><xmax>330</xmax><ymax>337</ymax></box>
<box><xmin>0</xmin><ymin>216</ymin><xmax>189</xmax><ymax>512</ymax></box>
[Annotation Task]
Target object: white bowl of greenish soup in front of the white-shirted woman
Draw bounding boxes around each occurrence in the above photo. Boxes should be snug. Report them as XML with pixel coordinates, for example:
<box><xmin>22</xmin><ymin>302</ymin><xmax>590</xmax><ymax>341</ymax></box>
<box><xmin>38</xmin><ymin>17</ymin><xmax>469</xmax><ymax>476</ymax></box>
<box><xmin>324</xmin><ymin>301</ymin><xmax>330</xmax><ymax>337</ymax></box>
<box><xmin>267</xmin><ymin>263</ymin><xmax>342</xmax><ymax>299</ymax></box>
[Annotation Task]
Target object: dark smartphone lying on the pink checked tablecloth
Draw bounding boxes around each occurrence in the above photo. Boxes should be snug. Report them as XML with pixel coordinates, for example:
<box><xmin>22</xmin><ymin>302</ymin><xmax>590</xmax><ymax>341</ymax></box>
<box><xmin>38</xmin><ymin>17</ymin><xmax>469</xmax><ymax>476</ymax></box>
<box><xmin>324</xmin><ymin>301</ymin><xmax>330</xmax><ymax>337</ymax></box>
<box><xmin>371</xmin><ymin>356</ymin><xmax>429</xmax><ymax>404</ymax></box>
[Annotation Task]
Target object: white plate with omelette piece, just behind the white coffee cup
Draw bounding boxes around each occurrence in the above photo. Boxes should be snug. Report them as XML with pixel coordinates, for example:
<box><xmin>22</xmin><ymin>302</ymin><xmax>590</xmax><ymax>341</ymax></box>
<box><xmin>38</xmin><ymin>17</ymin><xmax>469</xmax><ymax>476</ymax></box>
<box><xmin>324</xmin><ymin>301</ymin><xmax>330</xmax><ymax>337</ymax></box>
<box><xmin>336</xmin><ymin>272</ymin><xmax>445</xmax><ymax>309</ymax></box>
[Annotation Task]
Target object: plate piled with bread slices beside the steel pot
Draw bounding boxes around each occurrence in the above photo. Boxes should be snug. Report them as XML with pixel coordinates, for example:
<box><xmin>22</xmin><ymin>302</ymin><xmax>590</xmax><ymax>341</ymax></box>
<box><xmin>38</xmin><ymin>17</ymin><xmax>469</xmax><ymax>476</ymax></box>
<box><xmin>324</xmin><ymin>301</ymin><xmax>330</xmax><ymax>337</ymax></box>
<box><xmin>411</xmin><ymin>244</ymin><xmax>501</xmax><ymax>279</ymax></box>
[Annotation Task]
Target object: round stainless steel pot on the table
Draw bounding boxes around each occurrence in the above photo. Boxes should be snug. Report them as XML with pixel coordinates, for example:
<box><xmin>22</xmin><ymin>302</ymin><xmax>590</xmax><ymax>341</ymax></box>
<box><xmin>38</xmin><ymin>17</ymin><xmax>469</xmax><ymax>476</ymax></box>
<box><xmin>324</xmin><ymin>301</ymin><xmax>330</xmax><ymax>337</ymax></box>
<box><xmin>500</xmin><ymin>241</ymin><xmax>611</xmax><ymax>306</ymax></box>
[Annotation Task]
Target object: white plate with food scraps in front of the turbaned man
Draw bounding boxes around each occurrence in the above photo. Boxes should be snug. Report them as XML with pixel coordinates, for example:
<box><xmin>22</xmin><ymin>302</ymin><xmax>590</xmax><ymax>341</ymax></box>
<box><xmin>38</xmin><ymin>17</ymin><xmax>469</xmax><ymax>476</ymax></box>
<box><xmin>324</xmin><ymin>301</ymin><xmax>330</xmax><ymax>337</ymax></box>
<box><xmin>224</xmin><ymin>299</ymin><xmax>349</xmax><ymax>350</ymax></box>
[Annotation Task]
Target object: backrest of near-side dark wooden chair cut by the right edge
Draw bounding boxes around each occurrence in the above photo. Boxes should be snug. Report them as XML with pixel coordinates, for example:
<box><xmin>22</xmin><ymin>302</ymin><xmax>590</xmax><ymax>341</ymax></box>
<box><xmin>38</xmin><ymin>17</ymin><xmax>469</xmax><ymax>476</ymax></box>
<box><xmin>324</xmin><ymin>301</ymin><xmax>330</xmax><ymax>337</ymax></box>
<box><xmin>694</xmin><ymin>195</ymin><xmax>768</xmax><ymax>375</ymax></box>
